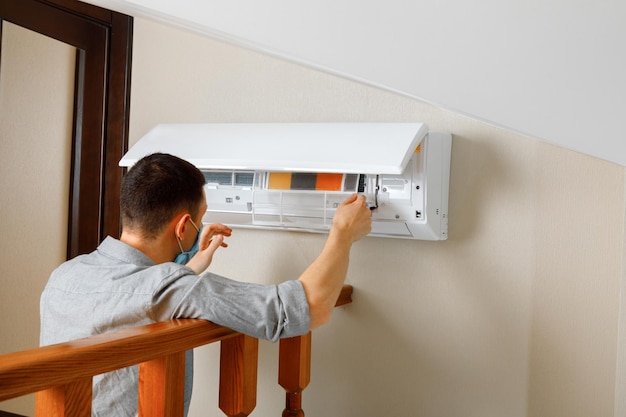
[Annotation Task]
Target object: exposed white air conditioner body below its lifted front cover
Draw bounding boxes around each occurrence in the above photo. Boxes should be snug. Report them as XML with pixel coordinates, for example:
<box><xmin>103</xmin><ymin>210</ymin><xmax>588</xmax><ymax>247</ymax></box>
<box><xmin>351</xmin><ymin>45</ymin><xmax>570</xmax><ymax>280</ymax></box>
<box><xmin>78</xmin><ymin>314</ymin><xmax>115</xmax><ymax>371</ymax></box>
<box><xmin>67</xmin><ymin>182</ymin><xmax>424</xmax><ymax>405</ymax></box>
<box><xmin>201</xmin><ymin>132</ymin><xmax>451</xmax><ymax>240</ymax></box>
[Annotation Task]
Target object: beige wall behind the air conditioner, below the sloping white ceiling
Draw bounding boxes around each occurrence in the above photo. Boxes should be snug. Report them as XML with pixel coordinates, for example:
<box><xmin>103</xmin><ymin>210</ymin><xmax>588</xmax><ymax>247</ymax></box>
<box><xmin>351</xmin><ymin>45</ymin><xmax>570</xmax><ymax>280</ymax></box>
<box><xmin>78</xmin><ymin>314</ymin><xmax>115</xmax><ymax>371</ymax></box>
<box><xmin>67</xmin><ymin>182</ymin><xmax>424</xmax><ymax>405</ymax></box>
<box><xmin>0</xmin><ymin>13</ymin><xmax>626</xmax><ymax>417</ymax></box>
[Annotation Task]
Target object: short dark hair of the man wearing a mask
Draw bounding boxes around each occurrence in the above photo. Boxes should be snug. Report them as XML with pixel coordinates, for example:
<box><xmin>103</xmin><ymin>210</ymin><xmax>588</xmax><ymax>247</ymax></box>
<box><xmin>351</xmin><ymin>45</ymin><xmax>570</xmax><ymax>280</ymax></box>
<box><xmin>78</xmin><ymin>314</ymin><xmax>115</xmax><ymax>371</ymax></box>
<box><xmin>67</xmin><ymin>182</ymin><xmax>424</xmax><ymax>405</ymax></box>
<box><xmin>120</xmin><ymin>153</ymin><xmax>204</xmax><ymax>238</ymax></box>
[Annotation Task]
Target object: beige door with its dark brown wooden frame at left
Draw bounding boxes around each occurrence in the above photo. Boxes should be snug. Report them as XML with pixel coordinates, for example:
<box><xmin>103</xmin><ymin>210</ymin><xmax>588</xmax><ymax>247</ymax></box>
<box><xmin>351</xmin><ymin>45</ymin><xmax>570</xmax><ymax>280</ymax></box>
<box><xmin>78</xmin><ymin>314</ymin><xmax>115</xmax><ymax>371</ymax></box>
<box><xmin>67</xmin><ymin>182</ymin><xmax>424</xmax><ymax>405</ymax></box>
<box><xmin>0</xmin><ymin>0</ymin><xmax>132</xmax><ymax>415</ymax></box>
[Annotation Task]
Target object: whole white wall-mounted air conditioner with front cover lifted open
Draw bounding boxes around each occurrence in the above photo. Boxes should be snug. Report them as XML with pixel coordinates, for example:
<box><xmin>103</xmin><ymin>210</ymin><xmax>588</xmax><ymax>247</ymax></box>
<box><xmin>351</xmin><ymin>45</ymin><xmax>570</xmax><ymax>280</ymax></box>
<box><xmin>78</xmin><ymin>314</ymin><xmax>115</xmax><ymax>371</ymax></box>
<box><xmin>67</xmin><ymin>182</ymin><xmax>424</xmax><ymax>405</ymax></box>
<box><xmin>120</xmin><ymin>123</ymin><xmax>452</xmax><ymax>240</ymax></box>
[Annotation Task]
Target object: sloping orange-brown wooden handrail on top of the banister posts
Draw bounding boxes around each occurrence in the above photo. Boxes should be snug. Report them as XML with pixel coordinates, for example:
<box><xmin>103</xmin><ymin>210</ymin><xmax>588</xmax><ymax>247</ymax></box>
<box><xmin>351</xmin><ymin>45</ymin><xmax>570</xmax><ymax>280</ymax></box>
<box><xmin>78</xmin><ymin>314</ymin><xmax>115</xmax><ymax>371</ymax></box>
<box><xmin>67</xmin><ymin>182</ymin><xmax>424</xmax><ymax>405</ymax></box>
<box><xmin>0</xmin><ymin>319</ymin><xmax>237</xmax><ymax>401</ymax></box>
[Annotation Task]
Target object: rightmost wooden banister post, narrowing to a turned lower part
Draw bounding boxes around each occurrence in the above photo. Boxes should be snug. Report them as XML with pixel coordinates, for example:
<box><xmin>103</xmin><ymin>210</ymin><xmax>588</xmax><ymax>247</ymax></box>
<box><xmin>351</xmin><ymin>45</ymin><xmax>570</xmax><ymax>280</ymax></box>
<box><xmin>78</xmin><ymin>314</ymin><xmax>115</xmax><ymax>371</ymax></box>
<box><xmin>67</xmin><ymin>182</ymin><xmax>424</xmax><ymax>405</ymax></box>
<box><xmin>278</xmin><ymin>332</ymin><xmax>311</xmax><ymax>417</ymax></box>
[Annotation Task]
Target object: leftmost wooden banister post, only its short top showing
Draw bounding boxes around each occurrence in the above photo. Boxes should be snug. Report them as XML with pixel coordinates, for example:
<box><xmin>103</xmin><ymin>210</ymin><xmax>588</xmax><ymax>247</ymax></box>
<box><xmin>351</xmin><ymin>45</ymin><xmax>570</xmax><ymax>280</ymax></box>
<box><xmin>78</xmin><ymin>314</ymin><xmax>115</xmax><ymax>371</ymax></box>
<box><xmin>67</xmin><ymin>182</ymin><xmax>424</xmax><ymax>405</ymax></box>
<box><xmin>35</xmin><ymin>377</ymin><xmax>92</xmax><ymax>417</ymax></box>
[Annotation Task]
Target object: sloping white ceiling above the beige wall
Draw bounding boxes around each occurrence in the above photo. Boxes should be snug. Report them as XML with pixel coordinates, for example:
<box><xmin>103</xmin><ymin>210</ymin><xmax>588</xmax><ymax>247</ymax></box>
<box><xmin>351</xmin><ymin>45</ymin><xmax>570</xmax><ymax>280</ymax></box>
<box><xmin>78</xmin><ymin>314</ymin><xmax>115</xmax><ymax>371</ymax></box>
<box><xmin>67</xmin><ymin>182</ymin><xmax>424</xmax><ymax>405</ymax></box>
<box><xmin>88</xmin><ymin>0</ymin><xmax>626</xmax><ymax>166</ymax></box>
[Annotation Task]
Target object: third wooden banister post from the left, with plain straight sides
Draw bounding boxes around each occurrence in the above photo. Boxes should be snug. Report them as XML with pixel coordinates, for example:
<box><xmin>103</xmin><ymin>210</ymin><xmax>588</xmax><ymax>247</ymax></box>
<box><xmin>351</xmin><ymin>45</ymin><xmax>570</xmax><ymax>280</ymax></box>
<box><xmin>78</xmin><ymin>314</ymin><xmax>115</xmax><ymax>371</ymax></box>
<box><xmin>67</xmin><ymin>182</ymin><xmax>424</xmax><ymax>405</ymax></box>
<box><xmin>219</xmin><ymin>334</ymin><xmax>259</xmax><ymax>417</ymax></box>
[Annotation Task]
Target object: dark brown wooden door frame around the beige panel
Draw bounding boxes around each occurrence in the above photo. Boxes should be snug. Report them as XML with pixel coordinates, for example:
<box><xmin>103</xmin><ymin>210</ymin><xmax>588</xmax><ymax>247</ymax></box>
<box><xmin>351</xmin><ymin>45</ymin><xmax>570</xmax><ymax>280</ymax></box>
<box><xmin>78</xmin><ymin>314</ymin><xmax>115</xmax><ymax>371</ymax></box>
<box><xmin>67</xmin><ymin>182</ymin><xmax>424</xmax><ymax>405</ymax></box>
<box><xmin>0</xmin><ymin>0</ymin><xmax>133</xmax><ymax>258</ymax></box>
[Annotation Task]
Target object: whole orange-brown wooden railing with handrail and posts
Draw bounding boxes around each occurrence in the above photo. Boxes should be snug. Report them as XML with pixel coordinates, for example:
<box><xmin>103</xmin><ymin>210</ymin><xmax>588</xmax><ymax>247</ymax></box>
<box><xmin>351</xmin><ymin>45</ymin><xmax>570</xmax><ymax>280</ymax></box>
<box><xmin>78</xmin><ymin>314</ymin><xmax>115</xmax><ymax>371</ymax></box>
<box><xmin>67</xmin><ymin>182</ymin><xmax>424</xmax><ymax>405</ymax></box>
<box><xmin>0</xmin><ymin>285</ymin><xmax>352</xmax><ymax>417</ymax></box>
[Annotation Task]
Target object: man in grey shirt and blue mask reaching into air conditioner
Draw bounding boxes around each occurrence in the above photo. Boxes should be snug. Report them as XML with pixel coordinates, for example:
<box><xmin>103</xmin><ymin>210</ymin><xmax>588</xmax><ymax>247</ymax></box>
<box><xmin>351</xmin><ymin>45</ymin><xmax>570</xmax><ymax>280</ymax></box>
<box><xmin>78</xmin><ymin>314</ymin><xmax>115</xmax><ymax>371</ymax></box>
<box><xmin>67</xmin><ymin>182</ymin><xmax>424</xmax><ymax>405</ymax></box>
<box><xmin>41</xmin><ymin>153</ymin><xmax>371</xmax><ymax>417</ymax></box>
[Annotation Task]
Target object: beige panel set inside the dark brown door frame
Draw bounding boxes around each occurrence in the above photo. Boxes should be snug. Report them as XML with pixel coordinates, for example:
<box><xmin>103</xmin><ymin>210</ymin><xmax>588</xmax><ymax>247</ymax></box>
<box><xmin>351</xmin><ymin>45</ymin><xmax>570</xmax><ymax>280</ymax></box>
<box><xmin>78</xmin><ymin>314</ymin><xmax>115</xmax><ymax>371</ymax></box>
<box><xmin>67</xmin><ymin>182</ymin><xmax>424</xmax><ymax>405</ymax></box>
<box><xmin>0</xmin><ymin>22</ymin><xmax>76</xmax><ymax>413</ymax></box>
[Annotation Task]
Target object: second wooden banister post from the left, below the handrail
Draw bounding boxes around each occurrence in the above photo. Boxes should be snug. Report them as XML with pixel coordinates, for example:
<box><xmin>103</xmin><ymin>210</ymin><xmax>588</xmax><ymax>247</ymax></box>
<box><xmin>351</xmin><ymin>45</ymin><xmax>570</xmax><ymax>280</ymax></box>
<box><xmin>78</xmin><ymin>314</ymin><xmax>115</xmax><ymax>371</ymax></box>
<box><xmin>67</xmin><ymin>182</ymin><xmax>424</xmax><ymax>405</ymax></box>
<box><xmin>139</xmin><ymin>351</ymin><xmax>185</xmax><ymax>417</ymax></box>
